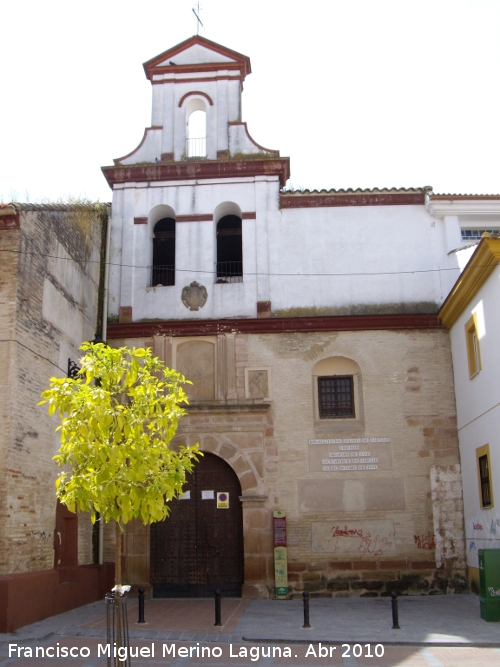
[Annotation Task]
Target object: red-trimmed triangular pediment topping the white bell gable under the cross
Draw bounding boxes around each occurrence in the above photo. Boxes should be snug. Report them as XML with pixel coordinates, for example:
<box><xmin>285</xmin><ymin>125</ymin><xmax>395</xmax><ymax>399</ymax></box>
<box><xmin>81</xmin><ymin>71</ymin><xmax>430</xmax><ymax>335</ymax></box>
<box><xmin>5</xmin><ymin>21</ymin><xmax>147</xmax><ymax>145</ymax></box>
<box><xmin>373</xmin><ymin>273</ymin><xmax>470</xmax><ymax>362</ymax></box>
<box><xmin>144</xmin><ymin>35</ymin><xmax>251</xmax><ymax>79</ymax></box>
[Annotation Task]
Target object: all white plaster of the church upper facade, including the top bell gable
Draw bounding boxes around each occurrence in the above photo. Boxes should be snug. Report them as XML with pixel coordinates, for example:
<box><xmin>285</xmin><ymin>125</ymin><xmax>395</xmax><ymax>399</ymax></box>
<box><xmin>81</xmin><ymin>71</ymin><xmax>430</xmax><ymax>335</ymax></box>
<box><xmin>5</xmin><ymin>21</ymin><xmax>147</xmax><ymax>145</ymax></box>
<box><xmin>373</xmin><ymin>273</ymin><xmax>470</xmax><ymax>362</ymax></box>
<box><xmin>106</xmin><ymin>37</ymin><xmax>476</xmax><ymax>321</ymax></box>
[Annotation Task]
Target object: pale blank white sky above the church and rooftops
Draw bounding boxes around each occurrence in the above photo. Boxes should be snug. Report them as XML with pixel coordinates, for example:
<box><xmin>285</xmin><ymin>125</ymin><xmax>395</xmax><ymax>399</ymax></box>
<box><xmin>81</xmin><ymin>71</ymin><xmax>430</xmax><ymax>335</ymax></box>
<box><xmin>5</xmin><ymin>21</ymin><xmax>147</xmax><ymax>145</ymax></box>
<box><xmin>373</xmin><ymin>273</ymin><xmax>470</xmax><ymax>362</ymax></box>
<box><xmin>0</xmin><ymin>0</ymin><xmax>500</xmax><ymax>203</ymax></box>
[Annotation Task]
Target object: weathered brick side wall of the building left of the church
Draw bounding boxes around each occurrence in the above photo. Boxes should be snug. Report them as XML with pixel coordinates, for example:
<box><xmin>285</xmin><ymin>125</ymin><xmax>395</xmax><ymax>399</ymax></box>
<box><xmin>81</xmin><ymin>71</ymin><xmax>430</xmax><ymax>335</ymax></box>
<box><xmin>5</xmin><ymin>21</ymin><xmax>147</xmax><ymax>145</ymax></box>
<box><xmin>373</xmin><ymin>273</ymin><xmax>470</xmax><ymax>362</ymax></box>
<box><xmin>0</xmin><ymin>207</ymin><xmax>106</xmax><ymax>574</ymax></box>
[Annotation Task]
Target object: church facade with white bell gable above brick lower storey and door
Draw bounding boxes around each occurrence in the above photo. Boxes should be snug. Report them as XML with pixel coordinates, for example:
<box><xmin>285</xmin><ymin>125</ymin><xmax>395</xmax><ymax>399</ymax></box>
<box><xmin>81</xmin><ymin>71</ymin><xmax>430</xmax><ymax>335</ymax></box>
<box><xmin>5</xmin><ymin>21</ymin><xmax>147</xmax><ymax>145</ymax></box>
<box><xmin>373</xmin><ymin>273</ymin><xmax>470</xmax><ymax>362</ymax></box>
<box><xmin>103</xmin><ymin>37</ymin><xmax>465</xmax><ymax>597</ymax></box>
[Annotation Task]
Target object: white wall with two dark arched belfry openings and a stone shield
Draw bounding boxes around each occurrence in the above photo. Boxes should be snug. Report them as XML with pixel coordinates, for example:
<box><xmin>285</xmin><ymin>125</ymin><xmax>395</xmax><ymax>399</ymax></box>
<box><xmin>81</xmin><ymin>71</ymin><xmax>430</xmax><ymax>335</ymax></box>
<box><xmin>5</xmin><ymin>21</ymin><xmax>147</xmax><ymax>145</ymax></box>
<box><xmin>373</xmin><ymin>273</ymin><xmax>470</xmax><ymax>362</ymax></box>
<box><xmin>109</xmin><ymin>177</ymin><xmax>279</xmax><ymax>320</ymax></box>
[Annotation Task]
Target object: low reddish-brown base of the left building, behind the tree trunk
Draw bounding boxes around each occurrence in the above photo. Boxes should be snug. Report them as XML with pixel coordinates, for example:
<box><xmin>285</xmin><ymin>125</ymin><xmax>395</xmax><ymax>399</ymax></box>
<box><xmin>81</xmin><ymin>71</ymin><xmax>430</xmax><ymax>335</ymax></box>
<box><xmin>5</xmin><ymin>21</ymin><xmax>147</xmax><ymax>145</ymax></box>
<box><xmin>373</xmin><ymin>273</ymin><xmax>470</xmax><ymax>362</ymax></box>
<box><xmin>0</xmin><ymin>563</ymin><xmax>115</xmax><ymax>632</ymax></box>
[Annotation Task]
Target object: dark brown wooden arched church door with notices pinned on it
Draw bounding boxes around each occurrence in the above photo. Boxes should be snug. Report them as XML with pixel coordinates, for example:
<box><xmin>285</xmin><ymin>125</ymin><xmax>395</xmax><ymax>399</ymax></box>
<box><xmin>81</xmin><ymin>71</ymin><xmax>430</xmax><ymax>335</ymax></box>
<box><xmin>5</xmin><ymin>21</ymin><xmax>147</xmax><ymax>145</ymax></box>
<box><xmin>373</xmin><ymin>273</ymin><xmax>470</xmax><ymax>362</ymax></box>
<box><xmin>150</xmin><ymin>453</ymin><xmax>243</xmax><ymax>597</ymax></box>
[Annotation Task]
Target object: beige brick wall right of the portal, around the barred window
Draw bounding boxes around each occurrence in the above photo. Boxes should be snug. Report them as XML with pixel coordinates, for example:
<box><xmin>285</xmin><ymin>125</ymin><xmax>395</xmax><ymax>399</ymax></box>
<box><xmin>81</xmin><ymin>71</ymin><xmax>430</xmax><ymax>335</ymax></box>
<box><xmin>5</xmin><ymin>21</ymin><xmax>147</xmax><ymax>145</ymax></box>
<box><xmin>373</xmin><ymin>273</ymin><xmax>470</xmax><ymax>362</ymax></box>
<box><xmin>247</xmin><ymin>330</ymin><xmax>466</xmax><ymax>596</ymax></box>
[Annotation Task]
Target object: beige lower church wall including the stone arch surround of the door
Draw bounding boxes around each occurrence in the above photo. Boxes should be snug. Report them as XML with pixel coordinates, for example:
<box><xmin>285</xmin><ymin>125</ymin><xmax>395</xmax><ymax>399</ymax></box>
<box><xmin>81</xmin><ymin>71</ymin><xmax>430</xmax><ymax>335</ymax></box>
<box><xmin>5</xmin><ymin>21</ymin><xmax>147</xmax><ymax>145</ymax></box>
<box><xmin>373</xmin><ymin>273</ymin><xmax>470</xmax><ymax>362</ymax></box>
<box><xmin>111</xmin><ymin>329</ymin><xmax>466</xmax><ymax>597</ymax></box>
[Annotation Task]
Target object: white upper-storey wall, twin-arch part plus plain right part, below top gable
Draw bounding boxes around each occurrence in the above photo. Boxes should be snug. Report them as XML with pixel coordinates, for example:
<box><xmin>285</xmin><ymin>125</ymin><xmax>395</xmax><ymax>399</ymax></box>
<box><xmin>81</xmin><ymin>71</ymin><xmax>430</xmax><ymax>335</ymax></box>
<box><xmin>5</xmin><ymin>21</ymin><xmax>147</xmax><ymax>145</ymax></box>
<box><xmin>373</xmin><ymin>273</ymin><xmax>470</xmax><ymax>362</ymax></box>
<box><xmin>110</xmin><ymin>185</ymin><xmax>468</xmax><ymax>320</ymax></box>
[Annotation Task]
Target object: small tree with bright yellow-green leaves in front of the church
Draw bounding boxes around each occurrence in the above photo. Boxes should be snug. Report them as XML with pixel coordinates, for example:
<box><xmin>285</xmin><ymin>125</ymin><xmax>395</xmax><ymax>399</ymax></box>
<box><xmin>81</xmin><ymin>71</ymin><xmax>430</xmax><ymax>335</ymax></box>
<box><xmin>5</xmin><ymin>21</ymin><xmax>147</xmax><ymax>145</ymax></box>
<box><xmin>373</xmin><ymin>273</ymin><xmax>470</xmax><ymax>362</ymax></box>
<box><xmin>39</xmin><ymin>343</ymin><xmax>199</xmax><ymax>595</ymax></box>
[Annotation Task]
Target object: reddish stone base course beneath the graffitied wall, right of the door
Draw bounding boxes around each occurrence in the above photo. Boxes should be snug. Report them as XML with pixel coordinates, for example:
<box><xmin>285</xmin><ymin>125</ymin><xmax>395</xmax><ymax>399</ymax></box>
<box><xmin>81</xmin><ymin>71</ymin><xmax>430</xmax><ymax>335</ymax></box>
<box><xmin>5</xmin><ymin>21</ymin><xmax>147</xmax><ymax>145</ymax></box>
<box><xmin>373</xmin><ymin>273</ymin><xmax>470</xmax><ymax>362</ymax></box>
<box><xmin>288</xmin><ymin>559</ymin><xmax>469</xmax><ymax>597</ymax></box>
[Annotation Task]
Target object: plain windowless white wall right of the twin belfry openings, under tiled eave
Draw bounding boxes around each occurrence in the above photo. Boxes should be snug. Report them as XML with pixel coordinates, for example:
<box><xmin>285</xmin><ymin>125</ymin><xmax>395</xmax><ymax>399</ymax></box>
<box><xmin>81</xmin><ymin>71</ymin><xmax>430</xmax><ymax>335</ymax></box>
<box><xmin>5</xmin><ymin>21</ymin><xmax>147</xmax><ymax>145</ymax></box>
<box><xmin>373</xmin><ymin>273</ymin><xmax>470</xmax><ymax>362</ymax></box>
<box><xmin>270</xmin><ymin>206</ymin><xmax>456</xmax><ymax>310</ymax></box>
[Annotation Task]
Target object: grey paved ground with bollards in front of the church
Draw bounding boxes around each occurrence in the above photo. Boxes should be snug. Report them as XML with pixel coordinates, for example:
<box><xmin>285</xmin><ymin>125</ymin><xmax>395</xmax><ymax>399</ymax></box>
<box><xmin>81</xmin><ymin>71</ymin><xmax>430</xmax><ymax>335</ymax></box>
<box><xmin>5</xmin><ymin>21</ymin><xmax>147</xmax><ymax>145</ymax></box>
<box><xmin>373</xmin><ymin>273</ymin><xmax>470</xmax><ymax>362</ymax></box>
<box><xmin>0</xmin><ymin>595</ymin><xmax>500</xmax><ymax>667</ymax></box>
